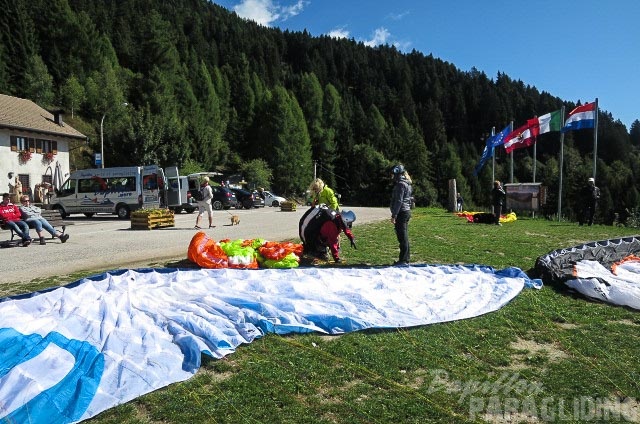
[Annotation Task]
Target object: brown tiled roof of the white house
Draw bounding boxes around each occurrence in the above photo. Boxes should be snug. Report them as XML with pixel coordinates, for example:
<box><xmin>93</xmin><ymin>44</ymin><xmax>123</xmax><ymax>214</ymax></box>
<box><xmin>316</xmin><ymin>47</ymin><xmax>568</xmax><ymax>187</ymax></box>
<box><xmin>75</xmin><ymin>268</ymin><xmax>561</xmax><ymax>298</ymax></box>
<box><xmin>0</xmin><ymin>94</ymin><xmax>87</xmax><ymax>140</ymax></box>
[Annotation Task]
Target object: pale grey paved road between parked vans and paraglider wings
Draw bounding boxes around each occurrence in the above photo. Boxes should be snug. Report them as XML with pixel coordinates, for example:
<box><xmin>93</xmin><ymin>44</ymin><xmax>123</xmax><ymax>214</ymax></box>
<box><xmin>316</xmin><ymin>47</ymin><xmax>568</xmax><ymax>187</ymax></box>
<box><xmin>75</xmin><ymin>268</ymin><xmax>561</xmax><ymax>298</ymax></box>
<box><xmin>0</xmin><ymin>206</ymin><xmax>389</xmax><ymax>284</ymax></box>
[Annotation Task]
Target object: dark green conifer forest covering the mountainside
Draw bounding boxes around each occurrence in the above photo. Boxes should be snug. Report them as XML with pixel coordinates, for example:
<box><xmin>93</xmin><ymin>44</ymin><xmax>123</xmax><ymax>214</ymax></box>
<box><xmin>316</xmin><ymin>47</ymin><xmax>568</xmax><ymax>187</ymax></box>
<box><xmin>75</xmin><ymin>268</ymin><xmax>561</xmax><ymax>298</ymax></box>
<box><xmin>0</xmin><ymin>0</ymin><xmax>640</xmax><ymax>224</ymax></box>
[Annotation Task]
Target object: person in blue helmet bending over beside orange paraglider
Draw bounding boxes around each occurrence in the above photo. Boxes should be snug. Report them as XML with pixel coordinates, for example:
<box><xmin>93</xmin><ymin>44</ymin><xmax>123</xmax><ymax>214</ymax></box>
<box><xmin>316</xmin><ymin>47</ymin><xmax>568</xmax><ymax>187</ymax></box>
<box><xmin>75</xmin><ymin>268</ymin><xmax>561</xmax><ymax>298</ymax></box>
<box><xmin>299</xmin><ymin>205</ymin><xmax>356</xmax><ymax>263</ymax></box>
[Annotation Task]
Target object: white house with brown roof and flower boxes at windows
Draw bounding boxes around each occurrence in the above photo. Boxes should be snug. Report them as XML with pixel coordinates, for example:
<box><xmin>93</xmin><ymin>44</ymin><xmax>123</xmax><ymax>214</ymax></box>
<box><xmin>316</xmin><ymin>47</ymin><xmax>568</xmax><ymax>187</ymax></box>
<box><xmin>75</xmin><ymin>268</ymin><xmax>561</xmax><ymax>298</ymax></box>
<box><xmin>0</xmin><ymin>94</ymin><xmax>87</xmax><ymax>201</ymax></box>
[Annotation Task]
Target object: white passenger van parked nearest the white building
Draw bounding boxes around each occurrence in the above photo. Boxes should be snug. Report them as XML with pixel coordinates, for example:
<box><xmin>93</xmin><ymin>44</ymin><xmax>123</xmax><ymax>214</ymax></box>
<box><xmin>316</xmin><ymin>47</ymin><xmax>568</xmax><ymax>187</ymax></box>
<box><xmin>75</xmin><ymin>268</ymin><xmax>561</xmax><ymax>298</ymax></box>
<box><xmin>51</xmin><ymin>165</ymin><xmax>166</xmax><ymax>219</ymax></box>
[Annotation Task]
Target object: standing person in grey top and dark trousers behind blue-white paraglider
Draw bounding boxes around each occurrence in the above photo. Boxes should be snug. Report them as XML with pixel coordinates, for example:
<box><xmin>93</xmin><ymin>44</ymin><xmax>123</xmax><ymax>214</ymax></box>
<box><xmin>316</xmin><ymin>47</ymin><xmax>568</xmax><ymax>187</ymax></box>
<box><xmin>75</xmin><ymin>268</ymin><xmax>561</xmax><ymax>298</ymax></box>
<box><xmin>390</xmin><ymin>165</ymin><xmax>413</xmax><ymax>265</ymax></box>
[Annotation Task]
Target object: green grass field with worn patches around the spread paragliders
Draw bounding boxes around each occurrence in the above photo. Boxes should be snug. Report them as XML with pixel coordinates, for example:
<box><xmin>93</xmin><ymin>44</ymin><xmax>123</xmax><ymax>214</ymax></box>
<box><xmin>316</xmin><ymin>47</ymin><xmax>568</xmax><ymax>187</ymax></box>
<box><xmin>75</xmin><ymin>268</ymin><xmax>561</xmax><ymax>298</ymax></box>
<box><xmin>4</xmin><ymin>209</ymin><xmax>640</xmax><ymax>424</ymax></box>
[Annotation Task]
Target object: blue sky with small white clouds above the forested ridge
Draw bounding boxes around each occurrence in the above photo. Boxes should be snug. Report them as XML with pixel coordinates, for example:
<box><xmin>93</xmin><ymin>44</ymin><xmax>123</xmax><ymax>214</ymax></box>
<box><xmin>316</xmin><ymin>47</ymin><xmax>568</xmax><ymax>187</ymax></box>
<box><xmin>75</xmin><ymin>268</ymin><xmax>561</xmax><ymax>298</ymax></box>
<box><xmin>212</xmin><ymin>0</ymin><xmax>640</xmax><ymax>130</ymax></box>
